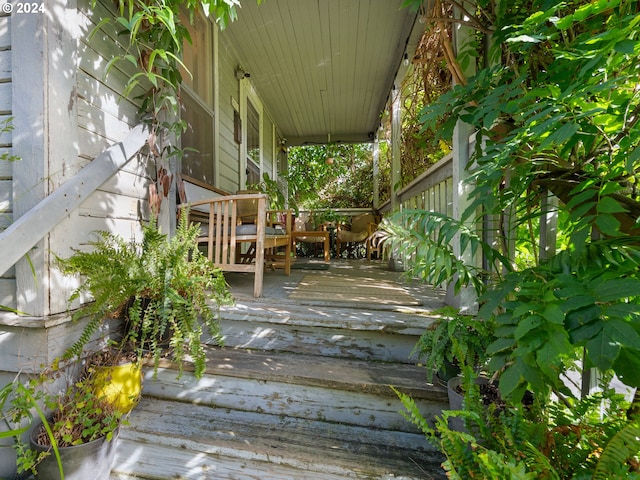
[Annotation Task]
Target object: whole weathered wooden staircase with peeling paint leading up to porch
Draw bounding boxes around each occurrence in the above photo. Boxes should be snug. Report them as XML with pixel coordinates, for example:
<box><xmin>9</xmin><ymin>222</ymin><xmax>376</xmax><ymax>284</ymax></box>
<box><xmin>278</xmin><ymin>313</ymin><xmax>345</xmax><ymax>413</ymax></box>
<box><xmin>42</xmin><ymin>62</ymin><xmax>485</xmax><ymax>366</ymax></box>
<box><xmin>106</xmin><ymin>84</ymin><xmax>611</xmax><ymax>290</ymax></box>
<box><xmin>112</xmin><ymin>268</ymin><xmax>448</xmax><ymax>480</ymax></box>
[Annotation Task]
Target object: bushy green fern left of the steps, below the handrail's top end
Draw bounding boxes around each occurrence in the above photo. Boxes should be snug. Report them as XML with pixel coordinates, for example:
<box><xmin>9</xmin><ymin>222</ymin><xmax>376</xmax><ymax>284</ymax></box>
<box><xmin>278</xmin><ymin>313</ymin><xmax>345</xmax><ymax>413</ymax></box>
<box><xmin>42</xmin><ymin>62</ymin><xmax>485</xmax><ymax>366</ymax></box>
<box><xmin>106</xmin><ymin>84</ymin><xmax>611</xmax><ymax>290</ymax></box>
<box><xmin>58</xmin><ymin>215</ymin><xmax>232</xmax><ymax>378</ymax></box>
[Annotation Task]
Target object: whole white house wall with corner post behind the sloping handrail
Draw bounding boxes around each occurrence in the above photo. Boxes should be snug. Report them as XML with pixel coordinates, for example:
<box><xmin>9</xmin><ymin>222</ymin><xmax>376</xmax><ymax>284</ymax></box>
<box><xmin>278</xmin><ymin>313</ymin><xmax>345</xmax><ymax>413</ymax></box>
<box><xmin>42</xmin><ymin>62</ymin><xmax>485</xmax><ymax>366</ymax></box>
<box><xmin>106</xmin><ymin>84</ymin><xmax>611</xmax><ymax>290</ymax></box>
<box><xmin>0</xmin><ymin>0</ymin><xmax>149</xmax><ymax>390</ymax></box>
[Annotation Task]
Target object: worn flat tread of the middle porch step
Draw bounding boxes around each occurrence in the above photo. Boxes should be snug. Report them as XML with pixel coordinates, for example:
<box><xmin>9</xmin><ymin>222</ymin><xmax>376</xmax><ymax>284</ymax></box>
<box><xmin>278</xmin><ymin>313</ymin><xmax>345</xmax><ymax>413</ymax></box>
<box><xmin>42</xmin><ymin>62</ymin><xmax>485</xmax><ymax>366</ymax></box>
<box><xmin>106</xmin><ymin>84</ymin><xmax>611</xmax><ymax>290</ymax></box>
<box><xmin>152</xmin><ymin>346</ymin><xmax>447</xmax><ymax>402</ymax></box>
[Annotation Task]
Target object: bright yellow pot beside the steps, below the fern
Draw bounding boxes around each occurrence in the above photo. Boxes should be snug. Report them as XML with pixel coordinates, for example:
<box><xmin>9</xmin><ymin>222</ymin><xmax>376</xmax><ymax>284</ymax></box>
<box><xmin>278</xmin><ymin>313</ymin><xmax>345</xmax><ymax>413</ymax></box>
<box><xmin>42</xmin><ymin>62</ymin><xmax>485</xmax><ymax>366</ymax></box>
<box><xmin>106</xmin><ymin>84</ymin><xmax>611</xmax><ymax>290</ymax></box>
<box><xmin>94</xmin><ymin>363</ymin><xmax>142</xmax><ymax>414</ymax></box>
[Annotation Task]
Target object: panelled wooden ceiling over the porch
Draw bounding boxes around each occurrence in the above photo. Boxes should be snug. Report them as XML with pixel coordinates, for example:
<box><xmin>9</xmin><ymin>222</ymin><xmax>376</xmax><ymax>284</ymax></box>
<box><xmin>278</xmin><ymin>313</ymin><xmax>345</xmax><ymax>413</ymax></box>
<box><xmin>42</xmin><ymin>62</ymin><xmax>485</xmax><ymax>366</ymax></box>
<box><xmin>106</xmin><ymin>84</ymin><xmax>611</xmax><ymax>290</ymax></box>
<box><xmin>222</xmin><ymin>0</ymin><xmax>417</xmax><ymax>145</ymax></box>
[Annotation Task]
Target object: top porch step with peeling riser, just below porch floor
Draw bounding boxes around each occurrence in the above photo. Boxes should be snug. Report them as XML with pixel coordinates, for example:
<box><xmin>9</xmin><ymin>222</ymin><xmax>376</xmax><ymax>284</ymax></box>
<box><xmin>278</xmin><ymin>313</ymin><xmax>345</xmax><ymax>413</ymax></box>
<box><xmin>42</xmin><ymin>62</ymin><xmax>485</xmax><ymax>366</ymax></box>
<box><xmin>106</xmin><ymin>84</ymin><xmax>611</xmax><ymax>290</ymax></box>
<box><xmin>215</xmin><ymin>300</ymin><xmax>440</xmax><ymax>363</ymax></box>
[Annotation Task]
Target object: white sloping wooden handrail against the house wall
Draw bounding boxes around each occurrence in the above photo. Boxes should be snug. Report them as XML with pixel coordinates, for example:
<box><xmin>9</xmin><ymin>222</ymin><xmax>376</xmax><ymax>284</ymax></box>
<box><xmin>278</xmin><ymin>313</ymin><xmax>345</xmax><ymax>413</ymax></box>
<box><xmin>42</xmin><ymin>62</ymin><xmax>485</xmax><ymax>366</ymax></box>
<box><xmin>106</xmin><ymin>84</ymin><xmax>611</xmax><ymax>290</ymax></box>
<box><xmin>0</xmin><ymin>125</ymin><xmax>149</xmax><ymax>275</ymax></box>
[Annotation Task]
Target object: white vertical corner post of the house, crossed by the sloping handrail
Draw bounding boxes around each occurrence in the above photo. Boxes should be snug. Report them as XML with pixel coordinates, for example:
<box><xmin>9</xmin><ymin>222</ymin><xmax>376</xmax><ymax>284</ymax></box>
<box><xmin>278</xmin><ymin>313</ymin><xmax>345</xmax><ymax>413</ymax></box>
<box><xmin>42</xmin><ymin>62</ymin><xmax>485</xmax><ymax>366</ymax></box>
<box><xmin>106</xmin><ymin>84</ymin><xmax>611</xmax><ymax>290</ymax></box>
<box><xmin>11</xmin><ymin>0</ymin><xmax>81</xmax><ymax>317</ymax></box>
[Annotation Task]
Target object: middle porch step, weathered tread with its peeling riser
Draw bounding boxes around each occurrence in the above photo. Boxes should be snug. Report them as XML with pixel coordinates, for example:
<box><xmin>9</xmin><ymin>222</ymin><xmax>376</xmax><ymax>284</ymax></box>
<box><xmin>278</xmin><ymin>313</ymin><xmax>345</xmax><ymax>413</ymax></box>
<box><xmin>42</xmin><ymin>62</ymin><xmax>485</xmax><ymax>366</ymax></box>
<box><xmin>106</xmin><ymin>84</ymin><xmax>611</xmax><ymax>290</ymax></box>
<box><xmin>144</xmin><ymin>347</ymin><xmax>448</xmax><ymax>432</ymax></box>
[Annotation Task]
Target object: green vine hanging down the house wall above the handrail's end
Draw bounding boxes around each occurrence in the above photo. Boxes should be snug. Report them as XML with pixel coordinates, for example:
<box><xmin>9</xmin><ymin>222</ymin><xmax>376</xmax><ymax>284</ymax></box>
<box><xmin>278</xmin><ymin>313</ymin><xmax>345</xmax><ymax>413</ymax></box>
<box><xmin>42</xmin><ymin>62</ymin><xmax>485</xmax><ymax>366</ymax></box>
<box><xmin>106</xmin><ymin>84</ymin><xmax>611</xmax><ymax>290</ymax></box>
<box><xmin>92</xmin><ymin>0</ymin><xmax>262</xmax><ymax>216</ymax></box>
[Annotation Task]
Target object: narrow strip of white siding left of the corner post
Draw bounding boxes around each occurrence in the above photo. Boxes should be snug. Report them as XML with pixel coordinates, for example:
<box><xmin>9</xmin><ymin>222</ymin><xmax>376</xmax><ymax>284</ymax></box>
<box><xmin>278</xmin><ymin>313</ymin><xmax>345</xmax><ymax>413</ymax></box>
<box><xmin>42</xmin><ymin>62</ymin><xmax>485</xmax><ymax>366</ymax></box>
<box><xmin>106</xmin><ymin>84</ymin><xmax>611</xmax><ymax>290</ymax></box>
<box><xmin>0</xmin><ymin>14</ymin><xmax>16</xmax><ymax>308</ymax></box>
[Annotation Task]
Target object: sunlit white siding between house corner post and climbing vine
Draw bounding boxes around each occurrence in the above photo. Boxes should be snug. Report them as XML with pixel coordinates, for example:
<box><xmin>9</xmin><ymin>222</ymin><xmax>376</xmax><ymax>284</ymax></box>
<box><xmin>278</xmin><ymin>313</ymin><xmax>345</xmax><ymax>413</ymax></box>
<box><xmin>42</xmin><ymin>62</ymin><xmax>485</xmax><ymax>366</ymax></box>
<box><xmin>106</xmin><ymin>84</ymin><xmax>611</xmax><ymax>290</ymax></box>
<box><xmin>43</xmin><ymin>0</ymin><xmax>150</xmax><ymax>314</ymax></box>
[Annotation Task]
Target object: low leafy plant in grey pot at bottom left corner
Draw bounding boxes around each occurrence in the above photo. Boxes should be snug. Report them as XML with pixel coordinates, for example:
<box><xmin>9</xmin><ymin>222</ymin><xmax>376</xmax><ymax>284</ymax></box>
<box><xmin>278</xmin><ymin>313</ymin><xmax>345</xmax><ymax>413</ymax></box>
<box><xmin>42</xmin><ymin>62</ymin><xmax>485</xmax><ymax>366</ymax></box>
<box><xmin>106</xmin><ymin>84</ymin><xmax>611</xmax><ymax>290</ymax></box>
<box><xmin>3</xmin><ymin>357</ymin><xmax>125</xmax><ymax>480</ymax></box>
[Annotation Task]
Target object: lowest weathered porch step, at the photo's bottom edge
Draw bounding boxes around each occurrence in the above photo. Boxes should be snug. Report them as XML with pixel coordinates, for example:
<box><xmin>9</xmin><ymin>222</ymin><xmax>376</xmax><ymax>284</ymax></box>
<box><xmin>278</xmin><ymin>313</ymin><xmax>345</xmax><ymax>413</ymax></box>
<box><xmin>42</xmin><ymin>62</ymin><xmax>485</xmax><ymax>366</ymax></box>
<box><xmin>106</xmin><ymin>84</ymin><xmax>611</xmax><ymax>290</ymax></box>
<box><xmin>112</xmin><ymin>398</ymin><xmax>445</xmax><ymax>480</ymax></box>
